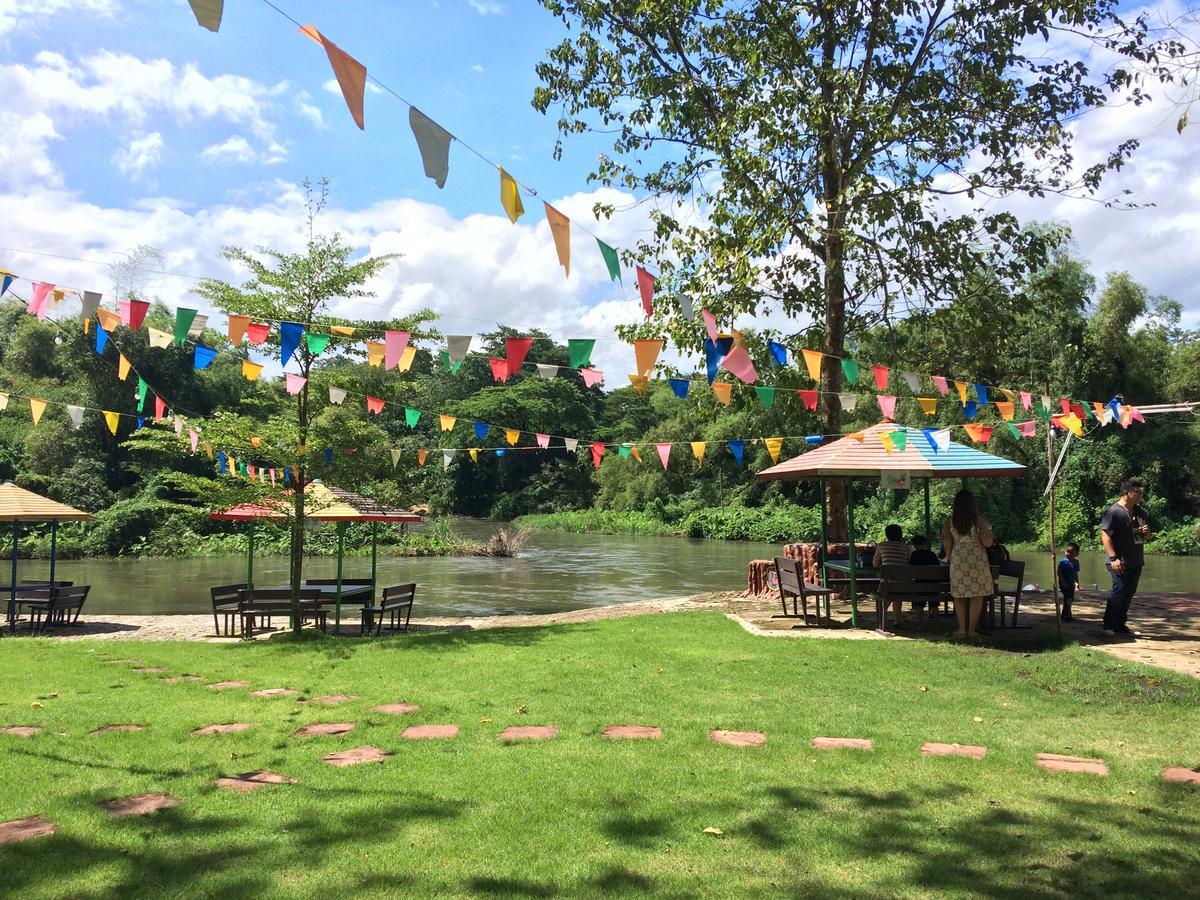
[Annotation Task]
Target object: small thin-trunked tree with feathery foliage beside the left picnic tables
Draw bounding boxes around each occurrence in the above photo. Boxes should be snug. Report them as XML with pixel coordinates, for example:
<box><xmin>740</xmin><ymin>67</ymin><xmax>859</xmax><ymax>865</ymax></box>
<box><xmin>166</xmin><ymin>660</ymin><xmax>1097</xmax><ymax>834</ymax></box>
<box><xmin>196</xmin><ymin>179</ymin><xmax>395</xmax><ymax>630</ymax></box>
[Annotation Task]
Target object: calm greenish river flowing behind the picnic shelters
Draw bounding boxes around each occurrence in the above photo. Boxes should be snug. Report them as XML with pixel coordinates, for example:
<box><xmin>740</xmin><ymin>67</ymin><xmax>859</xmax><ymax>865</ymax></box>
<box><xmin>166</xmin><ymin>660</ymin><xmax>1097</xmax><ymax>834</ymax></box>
<box><xmin>28</xmin><ymin>522</ymin><xmax>1200</xmax><ymax>618</ymax></box>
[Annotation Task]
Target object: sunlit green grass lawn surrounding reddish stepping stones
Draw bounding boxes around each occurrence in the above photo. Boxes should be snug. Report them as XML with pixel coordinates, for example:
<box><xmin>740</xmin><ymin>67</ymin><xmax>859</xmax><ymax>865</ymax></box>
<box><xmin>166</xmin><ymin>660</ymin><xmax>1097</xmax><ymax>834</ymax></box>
<box><xmin>0</xmin><ymin>612</ymin><xmax>1200</xmax><ymax>898</ymax></box>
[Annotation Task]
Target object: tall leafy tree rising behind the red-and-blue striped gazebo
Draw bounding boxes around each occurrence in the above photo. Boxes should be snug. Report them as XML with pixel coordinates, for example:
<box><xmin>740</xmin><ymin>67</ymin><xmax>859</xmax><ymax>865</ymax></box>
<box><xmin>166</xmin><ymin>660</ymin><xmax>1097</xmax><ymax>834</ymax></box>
<box><xmin>534</xmin><ymin>0</ymin><xmax>1183</xmax><ymax>535</ymax></box>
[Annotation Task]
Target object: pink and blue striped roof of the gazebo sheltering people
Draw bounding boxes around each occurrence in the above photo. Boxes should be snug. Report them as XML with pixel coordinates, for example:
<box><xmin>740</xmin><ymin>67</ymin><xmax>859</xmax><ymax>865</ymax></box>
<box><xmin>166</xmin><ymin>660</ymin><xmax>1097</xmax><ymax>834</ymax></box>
<box><xmin>758</xmin><ymin>422</ymin><xmax>1025</xmax><ymax>481</ymax></box>
